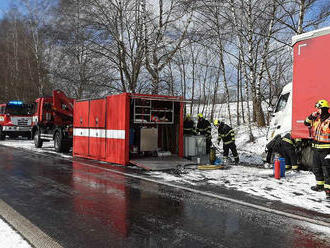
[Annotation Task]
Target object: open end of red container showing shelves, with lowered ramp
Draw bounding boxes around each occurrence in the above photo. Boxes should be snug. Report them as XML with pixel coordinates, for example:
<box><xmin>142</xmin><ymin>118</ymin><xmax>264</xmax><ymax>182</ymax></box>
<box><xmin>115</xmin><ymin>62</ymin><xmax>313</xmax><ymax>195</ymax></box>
<box><xmin>129</xmin><ymin>95</ymin><xmax>191</xmax><ymax>170</ymax></box>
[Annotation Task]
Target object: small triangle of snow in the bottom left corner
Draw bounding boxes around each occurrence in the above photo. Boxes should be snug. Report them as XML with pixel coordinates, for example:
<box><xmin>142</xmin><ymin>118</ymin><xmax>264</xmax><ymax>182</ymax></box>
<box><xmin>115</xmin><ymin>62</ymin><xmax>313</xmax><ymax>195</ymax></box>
<box><xmin>0</xmin><ymin>218</ymin><xmax>31</xmax><ymax>248</ymax></box>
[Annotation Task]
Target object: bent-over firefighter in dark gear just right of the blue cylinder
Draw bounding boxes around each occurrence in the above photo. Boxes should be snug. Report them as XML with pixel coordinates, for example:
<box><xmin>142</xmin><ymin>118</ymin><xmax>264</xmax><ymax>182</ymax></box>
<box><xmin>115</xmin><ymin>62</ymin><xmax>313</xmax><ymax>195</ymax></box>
<box><xmin>278</xmin><ymin>133</ymin><xmax>300</xmax><ymax>170</ymax></box>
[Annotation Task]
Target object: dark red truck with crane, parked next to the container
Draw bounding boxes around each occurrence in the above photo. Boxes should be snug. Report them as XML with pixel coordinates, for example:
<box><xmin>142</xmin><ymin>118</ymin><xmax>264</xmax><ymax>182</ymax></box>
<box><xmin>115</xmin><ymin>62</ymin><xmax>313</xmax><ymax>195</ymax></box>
<box><xmin>32</xmin><ymin>90</ymin><xmax>74</xmax><ymax>152</ymax></box>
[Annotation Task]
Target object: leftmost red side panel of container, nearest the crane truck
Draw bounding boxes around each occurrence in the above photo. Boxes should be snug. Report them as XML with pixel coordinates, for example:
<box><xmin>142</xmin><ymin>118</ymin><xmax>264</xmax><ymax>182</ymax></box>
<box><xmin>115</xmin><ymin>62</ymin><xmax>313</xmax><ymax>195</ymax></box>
<box><xmin>73</xmin><ymin>101</ymin><xmax>89</xmax><ymax>156</ymax></box>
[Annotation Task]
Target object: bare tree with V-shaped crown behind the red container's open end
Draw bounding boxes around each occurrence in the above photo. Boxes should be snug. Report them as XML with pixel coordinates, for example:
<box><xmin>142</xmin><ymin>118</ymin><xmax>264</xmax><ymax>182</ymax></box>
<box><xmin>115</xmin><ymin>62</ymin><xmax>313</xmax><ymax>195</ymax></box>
<box><xmin>142</xmin><ymin>0</ymin><xmax>192</xmax><ymax>94</ymax></box>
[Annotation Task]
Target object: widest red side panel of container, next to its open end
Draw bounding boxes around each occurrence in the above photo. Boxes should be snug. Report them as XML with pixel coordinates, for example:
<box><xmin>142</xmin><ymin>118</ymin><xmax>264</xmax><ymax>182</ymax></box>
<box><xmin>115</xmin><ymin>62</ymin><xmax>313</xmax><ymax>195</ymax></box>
<box><xmin>106</xmin><ymin>93</ymin><xmax>129</xmax><ymax>165</ymax></box>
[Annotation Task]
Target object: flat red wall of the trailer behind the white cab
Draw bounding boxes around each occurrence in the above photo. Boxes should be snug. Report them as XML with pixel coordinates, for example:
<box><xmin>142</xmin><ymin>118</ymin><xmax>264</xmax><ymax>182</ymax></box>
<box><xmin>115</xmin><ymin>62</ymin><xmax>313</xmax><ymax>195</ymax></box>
<box><xmin>292</xmin><ymin>34</ymin><xmax>330</xmax><ymax>138</ymax></box>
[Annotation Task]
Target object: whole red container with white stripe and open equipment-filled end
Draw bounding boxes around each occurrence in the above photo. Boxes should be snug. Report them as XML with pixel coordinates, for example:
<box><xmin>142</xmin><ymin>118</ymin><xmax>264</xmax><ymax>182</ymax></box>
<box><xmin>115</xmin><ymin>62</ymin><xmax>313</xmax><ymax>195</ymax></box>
<box><xmin>73</xmin><ymin>93</ymin><xmax>191</xmax><ymax>169</ymax></box>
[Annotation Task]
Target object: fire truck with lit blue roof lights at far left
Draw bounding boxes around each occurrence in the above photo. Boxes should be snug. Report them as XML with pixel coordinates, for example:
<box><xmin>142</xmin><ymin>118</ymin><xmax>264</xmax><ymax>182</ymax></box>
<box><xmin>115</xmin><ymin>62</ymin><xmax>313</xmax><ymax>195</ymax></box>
<box><xmin>0</xmin><ymin>101</ymin><xmax>32</xmax><ymax>140</ymax></box>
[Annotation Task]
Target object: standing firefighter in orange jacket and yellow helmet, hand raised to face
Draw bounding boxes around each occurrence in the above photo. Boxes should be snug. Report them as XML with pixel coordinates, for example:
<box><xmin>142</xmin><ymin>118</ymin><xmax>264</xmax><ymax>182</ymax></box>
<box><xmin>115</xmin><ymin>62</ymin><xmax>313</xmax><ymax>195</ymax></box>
<box><xmin>305</xmin><ymin>100</ymin><xmax>330</xmax><ymax>200</ymax></box>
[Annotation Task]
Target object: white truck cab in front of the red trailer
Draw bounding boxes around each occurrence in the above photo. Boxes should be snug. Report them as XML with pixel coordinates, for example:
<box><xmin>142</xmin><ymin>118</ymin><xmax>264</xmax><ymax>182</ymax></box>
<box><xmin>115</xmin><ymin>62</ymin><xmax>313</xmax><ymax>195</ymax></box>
<box><xmin>267</xmin><ymin>83</ymin><xmax>292</xmax><ymax>141</ymax></box>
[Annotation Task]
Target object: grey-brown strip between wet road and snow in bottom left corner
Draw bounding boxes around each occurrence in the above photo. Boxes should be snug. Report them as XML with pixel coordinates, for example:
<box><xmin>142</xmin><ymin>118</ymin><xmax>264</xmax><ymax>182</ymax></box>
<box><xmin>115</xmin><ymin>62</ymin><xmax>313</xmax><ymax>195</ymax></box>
<box><xmin>0</xmin><ymin>199</ymin><xmax>62</xmax><ymax>248</ymax></box>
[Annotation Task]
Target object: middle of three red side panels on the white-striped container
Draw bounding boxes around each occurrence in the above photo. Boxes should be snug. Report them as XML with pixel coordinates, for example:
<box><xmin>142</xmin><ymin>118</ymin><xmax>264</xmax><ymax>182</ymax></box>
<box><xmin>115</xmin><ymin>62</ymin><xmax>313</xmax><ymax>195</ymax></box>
<box><xmin>89</xmin><ymin>99</ymin><xmax>106</xmax><ymax>160</ymax></box>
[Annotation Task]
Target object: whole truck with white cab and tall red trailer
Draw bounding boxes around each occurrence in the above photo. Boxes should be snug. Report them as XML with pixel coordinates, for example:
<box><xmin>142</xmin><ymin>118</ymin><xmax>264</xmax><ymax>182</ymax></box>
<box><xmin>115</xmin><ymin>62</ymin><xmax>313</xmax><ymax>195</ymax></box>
<box><xmin>268</xmin><ymin>27</ymin><xmax>330</xmax><ymax>168</ymax></box>
